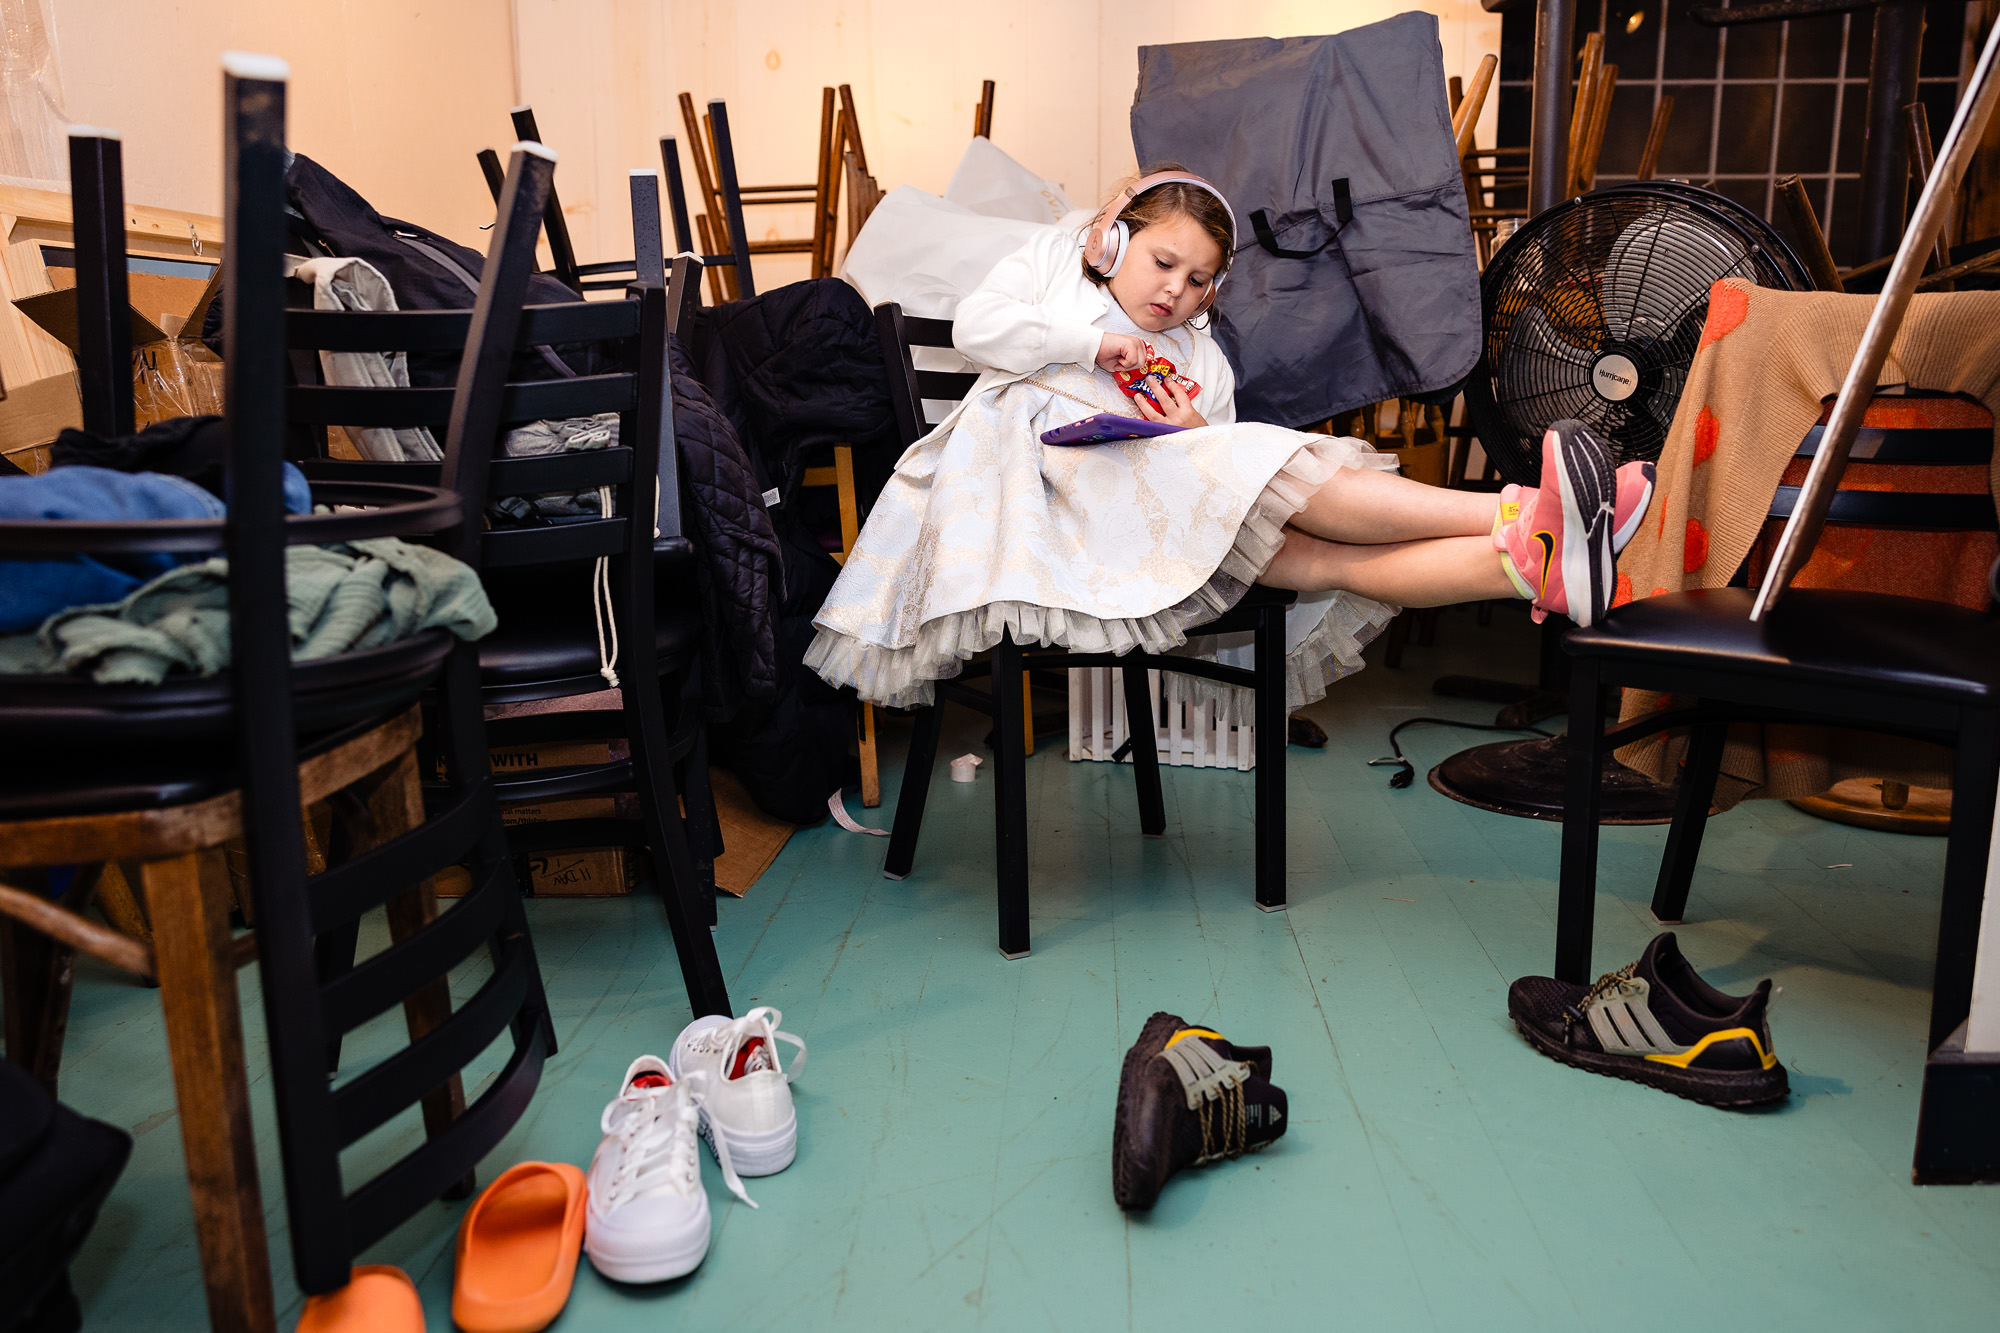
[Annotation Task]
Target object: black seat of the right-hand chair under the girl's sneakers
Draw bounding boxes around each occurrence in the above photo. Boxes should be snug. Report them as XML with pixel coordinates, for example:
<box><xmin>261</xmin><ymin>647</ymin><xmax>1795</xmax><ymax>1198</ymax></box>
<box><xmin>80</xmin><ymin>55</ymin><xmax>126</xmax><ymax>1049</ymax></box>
<box><xmin>1564</xmin><ymin>588</ymin><xmax>2000</xmax><ymax>705</ymax></box>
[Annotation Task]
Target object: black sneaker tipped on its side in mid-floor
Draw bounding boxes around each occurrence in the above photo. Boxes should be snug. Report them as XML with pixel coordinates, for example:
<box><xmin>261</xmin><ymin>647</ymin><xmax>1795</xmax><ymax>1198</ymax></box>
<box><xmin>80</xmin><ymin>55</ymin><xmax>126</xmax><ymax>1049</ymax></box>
<box><xmin>1112</xmin><ymin>1013</ymin><xmax>1288</xmax><ymax>1209</ymax></box>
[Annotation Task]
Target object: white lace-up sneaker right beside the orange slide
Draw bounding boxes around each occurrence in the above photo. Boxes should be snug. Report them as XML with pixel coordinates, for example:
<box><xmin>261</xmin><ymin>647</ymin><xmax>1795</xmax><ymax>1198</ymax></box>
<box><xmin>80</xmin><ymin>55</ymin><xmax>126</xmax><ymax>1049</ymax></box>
<box><xmin>584</xmin><ymin>1055</ymin><xmax>756</xmax><ymax>1283</ymax></box>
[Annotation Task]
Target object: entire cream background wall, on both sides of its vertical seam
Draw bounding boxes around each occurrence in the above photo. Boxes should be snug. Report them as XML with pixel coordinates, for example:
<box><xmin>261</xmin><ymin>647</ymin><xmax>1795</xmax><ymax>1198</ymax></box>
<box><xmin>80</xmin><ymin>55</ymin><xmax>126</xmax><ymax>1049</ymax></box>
<box><xmin>52</xmin><ymin>0</ymin><xmax>1500</xmax><ymax>272</ymax></box>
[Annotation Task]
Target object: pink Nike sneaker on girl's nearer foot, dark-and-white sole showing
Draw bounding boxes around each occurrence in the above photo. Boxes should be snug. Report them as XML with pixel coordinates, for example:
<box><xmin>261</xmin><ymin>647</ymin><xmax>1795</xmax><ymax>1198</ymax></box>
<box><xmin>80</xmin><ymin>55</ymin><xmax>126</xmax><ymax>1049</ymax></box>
<box><xmin>1494</xmin><ymin>420</ymin><xmax>1616</xmax><ymax>624</ymax></box>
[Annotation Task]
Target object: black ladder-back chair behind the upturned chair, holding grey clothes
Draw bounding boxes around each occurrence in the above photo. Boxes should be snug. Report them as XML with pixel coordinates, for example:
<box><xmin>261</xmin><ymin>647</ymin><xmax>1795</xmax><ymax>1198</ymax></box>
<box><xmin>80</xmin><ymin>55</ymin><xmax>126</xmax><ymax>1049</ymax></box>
<box><xmin>286</xmin><ymin>208</ymin><xmax>730</xmax><ymax>1017</ymax></box>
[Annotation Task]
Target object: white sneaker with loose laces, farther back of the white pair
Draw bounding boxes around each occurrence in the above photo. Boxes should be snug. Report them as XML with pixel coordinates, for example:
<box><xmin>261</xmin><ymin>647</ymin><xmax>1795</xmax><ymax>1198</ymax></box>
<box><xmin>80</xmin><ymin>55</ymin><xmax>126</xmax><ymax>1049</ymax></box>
<box><xmin>668</xmin><ymin>1005</ymin><xmax>806</xmax><ymax>1175</ymax></box>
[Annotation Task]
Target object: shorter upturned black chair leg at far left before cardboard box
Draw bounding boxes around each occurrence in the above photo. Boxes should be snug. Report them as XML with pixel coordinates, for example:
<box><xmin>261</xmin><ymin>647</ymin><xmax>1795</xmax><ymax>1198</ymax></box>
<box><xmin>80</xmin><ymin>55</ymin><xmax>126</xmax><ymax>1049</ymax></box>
<box><xmin>70</xmin><ymin>132</ymin><xmax>132</xmax><ymax>436</ymax></box>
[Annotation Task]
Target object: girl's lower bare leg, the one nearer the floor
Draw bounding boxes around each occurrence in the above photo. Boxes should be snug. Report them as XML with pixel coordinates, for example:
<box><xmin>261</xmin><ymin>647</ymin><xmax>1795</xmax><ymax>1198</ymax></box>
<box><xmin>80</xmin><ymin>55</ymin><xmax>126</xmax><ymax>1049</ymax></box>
<box><xmin>1258</xmin><ymin>524</ymin><xmax>1520</xmax><ymax>606</ymax></box>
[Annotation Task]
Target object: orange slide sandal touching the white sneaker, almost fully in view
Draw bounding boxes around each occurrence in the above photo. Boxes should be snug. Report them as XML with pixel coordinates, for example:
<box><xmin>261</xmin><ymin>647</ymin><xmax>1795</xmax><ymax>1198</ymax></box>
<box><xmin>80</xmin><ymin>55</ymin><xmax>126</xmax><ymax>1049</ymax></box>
<box><xmin>452</xmin><ymin>1161</ymin><xmax>584</xmax><ymax>1333</ymax></box>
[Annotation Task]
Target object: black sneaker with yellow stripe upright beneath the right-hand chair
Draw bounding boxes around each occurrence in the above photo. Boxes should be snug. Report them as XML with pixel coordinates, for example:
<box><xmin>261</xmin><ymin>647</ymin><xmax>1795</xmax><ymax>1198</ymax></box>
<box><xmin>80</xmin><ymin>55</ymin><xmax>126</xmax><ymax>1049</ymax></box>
<box><xmin>1506</xmin><ymin>931</ymin><xmax>1790</xmax><ymax>1107</ymax></box>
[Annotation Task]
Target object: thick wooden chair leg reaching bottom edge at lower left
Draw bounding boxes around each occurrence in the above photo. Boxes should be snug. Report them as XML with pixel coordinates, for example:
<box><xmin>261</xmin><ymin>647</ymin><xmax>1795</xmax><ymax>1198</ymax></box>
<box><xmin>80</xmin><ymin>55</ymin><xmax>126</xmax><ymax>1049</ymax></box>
<box><xmin>140</xmin><ymin>855</ymin><xmax>276</xmax><ymax>1333</ymax></box>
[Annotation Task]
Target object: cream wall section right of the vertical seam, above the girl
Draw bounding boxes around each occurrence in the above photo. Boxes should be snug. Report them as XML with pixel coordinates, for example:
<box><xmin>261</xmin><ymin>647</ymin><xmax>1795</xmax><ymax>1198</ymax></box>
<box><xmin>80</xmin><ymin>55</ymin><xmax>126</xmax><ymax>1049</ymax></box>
<box><xmin>514</xmin><ymin>0</ymin><xmax>1500</xmax><ymax>286</ymax></box>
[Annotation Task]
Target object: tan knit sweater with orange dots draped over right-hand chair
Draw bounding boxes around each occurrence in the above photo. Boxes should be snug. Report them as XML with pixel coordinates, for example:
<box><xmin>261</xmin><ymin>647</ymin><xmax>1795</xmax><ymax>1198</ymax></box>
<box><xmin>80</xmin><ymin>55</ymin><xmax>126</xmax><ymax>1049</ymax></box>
<box><xmin>1612</xmin><ymin>278</ymin><xmax>2000</xmax><ymax>807</ymax></box>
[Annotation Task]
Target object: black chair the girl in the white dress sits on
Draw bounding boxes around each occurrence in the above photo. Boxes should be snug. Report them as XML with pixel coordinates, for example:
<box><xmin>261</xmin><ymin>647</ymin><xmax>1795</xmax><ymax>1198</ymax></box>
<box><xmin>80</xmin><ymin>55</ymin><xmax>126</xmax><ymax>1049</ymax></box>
<box><xmin>876</xmin><ymin>304</ymin><xmax>1298</xmax><ymax>959</ymax></box>
